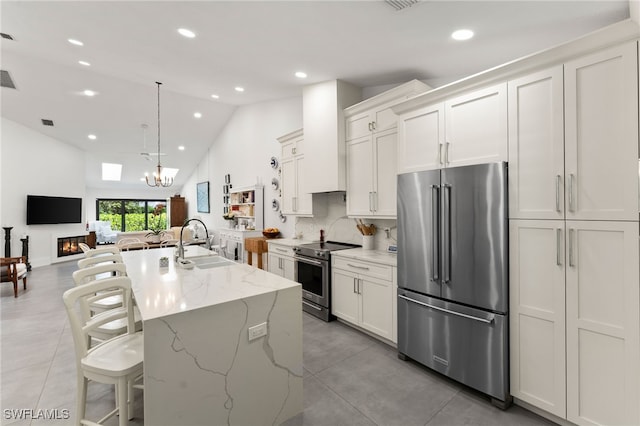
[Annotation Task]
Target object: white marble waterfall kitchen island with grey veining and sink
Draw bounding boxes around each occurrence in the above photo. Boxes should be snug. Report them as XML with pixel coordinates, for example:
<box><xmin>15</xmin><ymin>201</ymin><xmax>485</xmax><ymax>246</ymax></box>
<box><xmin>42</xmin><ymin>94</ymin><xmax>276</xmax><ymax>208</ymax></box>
<box><xmin>123</xmin><ymin>246</ymin><xmax>302</xmax><ymax>426</ymax></box>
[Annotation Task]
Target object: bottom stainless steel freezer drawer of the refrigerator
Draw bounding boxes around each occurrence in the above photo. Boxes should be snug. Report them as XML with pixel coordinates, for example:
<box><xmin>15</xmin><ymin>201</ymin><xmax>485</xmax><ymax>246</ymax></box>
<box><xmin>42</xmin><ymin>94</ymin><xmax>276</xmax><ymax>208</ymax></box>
<box><xmin>398</xmin><ymin>289</ymin><xmax>510</xmax><ymax>401</ymax></box>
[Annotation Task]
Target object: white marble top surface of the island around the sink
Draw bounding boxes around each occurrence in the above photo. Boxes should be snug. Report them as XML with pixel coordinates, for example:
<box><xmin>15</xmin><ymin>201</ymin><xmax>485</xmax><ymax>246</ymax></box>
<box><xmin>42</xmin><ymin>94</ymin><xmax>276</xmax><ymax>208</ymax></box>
<box><xmin>122</xmin><ymin>246</ymin><xmax>300</xmax><ymax>321</ymax></box>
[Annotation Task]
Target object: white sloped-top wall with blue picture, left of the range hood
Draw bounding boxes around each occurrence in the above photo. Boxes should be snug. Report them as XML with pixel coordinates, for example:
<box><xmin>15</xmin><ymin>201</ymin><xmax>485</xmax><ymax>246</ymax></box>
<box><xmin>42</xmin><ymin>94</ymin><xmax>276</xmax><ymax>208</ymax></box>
<box><xmin>182</xmin><ymin>97</ymin><xmax>302</xmax><ymax>237</ymax></box>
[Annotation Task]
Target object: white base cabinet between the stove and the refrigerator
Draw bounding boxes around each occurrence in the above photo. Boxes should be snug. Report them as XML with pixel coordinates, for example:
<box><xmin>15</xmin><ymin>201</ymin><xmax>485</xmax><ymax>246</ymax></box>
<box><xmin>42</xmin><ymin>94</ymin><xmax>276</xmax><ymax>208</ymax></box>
<box><xmin>331</xmin><ymin>254</ymin><xmax>396</xmax><ymax>342</ymax></box>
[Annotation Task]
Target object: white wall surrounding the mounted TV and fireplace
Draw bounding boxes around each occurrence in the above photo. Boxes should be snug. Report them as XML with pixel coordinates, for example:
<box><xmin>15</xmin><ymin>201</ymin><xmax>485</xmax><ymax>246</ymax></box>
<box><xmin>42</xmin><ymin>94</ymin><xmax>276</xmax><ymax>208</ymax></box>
<box><xmin>0</xmin><ymin>118</ymin><xmax>87</xmax><ymax>266</ymax></box>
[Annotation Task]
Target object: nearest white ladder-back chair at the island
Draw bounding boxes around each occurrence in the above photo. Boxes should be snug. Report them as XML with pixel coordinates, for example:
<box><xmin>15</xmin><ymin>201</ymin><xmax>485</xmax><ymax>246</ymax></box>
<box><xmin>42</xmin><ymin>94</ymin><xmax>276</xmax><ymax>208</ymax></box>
<box><xmin>62</xmin><ymin>277</ymin><xmax>144</xmax><ymax>426</ymax></box>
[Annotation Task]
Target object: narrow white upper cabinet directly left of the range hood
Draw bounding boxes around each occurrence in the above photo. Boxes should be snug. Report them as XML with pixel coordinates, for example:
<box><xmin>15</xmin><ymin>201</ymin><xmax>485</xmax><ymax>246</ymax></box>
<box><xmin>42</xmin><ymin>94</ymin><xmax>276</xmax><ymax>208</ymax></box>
<box><xmin>278</xmin><ymin>129</ymin><xmax>313</xmax><ymax>216</ymax></box>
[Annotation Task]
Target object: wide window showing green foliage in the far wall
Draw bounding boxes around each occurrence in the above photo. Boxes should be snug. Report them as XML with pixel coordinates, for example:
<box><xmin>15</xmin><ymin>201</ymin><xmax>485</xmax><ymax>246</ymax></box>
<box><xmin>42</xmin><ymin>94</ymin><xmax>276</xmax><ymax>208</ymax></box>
<box><xmin>96</xmin><ymin>199</ymin><xmax>167</xmax><ymax>232</ymax></box>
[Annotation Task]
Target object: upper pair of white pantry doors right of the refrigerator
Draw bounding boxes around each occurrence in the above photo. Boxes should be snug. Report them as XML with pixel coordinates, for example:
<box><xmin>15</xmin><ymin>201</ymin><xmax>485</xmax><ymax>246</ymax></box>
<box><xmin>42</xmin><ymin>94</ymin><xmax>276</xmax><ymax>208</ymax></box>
<box><xmin>509</xmin><ymin>43</ymin><xmax>638</xmax><ymax>220</ymax></box>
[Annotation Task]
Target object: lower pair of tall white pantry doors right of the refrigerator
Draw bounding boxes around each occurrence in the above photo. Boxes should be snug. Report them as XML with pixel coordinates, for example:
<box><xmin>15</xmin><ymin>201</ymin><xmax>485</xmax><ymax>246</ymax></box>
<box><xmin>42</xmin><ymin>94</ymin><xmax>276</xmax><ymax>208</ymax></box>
<box><xmin>510</xmin><ymin>220</ymin><xmax>640</xmax><ymax>425</ymax></box>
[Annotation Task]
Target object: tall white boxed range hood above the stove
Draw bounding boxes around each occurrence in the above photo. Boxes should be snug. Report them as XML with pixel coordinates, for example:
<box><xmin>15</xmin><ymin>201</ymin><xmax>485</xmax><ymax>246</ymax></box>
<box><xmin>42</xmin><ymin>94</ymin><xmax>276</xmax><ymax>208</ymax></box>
<box><xmin>302</xmin><ymin>80</ymin><xmax>362</xmax><ymax>194</ymax></box>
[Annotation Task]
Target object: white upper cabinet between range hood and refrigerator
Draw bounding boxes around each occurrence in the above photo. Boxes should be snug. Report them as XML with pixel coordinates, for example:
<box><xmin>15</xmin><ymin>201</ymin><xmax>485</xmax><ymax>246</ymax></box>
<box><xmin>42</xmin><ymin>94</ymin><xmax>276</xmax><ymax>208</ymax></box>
<box><xmin>345</xmin><ymin>80</ymin><xmax>429</xmax><ymax>218</ymax></box>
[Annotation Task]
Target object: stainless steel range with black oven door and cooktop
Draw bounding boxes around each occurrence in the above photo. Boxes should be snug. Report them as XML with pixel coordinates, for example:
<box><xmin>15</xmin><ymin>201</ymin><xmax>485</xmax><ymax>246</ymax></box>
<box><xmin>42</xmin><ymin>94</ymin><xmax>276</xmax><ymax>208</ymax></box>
<box><xmin>293</xmin><ymin>241</ymin><xmax>360</xmax><ymax>321</ymax></box>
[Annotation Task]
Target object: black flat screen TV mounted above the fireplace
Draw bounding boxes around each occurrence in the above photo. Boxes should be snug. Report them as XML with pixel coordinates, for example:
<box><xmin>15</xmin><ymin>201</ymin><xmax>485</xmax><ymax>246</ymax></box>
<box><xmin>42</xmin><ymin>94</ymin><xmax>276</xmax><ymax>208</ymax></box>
<box><xmin>27</xmin><ymin>195</ymin><xmax>82</xmax><ymax>225</ymax></box>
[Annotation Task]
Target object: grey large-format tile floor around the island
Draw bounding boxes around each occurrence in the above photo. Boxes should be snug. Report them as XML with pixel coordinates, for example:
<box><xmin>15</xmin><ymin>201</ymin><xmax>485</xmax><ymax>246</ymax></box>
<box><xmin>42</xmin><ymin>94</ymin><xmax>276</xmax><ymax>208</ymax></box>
<box><xmin>0</xmin><ymin>262</ymin><xmax>552</xmax><ymax>426</ymax></box>
